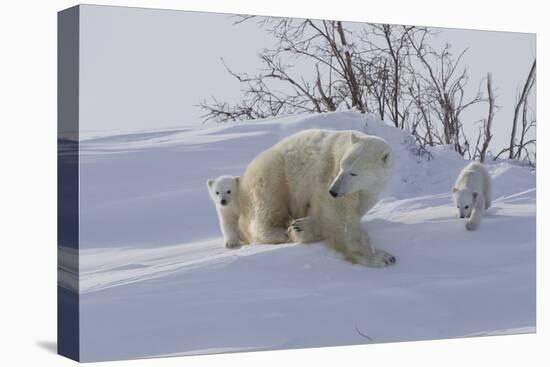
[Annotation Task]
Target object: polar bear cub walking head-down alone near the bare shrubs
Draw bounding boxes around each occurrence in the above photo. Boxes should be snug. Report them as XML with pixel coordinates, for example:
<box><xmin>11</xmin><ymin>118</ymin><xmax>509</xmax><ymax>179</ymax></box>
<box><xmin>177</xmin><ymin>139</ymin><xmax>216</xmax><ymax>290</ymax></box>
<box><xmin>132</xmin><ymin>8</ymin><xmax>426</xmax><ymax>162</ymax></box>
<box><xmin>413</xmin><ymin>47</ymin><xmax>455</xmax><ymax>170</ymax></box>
<box><xmin>453</xmin><ymin>162</ymin><xmax>491</xmax><ymax>231</ymax></box>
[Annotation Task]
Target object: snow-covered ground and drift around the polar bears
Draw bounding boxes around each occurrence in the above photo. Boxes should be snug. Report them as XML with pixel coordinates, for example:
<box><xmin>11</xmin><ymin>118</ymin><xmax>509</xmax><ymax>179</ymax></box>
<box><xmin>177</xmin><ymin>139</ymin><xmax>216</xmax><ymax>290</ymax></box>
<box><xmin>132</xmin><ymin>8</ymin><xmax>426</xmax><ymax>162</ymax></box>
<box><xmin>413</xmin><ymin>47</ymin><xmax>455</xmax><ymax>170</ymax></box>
<box><xmin>65</xmin><ymin>112</ymin><xmax>536</xmax><ymax>361</ymax></box>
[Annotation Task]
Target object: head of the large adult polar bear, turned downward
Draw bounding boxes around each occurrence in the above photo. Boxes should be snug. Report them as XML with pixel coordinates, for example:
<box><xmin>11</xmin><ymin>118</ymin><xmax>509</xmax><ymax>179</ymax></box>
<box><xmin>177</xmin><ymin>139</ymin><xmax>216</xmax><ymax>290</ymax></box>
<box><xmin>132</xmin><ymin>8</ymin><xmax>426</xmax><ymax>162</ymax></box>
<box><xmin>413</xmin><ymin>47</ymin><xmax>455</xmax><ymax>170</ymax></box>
<box><xmin>329</xmin><ymin>132</ymin><xmax>393</xmax><ymax>198</ymax></box>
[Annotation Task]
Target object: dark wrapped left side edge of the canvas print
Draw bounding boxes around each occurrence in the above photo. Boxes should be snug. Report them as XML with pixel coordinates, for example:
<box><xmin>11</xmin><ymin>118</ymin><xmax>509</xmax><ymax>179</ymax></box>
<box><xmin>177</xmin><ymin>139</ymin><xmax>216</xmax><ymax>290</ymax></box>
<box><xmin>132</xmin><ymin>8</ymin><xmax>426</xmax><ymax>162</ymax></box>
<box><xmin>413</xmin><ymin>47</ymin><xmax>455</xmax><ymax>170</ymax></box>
<box><xmin>57</xmin><ymin>6</ymin><xmax>80</xmax><ymax>360</ymax></box>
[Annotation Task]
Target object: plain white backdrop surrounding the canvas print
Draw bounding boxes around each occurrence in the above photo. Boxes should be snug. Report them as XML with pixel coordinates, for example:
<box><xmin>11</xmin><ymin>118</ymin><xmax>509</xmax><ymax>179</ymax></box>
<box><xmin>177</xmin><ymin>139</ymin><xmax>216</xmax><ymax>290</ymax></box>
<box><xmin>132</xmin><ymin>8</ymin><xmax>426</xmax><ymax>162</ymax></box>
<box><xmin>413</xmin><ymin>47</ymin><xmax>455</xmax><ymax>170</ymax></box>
<box><xmin>0</xmin><ymin>0</ymin><xmax>550</xmax><ymax>366</ymax></box>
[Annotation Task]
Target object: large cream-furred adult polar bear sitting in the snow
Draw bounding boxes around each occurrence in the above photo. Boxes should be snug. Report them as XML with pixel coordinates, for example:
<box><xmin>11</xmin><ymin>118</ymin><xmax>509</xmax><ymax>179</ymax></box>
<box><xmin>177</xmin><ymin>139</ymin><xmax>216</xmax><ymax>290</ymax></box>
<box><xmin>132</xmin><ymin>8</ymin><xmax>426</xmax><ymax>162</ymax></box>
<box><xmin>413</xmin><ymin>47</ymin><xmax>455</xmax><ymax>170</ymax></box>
<box><xmin>239</xmin><ymin>129</ymin><xmax>395</xmax><ymax>267</ymax></box>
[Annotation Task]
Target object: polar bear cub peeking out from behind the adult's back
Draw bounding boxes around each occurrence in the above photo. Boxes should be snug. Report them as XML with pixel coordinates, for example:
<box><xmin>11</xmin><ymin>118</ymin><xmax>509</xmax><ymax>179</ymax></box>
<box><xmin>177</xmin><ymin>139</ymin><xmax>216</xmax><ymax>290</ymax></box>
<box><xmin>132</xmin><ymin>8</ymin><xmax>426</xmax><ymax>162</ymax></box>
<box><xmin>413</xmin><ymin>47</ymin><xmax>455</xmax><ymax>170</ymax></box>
<box><xmin>207</xmin><ymin>176</ymin><xmax>242</xmax><ymax>248</ymax></box>
